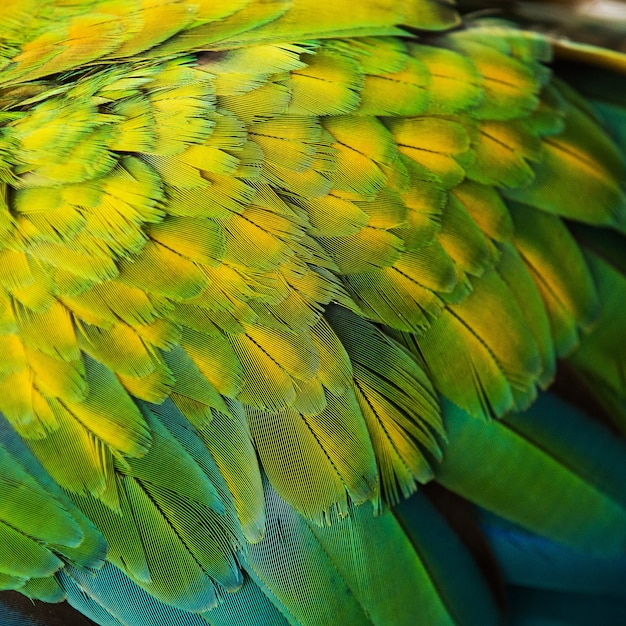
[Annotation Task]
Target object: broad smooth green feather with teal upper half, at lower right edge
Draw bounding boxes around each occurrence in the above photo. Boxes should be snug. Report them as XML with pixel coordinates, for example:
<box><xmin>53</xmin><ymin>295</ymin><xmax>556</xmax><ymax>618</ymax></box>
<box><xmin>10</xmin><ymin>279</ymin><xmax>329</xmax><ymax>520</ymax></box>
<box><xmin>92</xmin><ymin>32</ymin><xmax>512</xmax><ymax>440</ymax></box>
<box><xmin>435</xmin><ymin>396</ymin><xmax>626</xmax><ymax>557</ymax></box>
